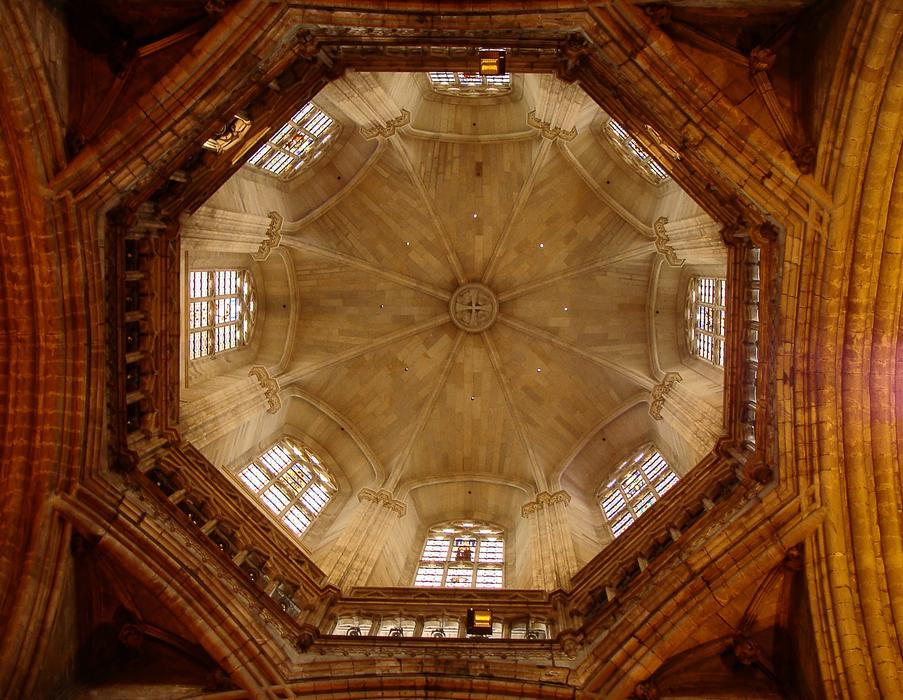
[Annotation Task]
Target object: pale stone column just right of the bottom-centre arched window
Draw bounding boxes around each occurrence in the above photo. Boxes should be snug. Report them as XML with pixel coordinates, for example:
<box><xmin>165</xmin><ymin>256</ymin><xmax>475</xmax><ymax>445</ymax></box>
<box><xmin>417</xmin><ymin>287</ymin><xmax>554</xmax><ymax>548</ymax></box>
<box><xmin>521</xmin><ymin>491</ymin><xmax>577</xmax><ymax>591</ymax></box>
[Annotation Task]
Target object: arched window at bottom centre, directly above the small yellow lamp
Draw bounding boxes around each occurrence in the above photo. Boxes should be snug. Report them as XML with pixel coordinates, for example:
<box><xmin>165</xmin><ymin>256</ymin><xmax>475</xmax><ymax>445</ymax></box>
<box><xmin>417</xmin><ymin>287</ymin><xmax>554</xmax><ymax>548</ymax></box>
<box><xmin>414</xmin><ymin>520</ymin><xmax>505</xmax><ymax>588</ymax></box>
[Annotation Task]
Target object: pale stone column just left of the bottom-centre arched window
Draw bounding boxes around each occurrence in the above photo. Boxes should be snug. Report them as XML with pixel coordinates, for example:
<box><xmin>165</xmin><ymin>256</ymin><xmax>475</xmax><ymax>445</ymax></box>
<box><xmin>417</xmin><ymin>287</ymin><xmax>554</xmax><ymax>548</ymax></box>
<box><xmin>328</xmin><ymin>488</ymin><xmax>407</xmax><ymax>590</ymax></box>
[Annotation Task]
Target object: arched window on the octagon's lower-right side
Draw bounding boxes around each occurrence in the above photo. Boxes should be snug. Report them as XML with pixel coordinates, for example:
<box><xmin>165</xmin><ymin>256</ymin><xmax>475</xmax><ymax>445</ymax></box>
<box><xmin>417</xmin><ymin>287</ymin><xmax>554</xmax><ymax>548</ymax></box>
<box><xmin>597</xmin><ymin>445</ymin><xmax>678</xmax><ymax>537</ymax></box>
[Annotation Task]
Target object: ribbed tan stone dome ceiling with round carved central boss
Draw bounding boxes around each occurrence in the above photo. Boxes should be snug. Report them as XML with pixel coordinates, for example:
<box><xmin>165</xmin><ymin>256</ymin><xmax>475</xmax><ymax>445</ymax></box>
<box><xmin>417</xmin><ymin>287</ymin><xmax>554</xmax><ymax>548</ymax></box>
<box><xmin>185</xmin><ymin>74</ymin><xmax>723</xmax><ymax>540</ymax></box>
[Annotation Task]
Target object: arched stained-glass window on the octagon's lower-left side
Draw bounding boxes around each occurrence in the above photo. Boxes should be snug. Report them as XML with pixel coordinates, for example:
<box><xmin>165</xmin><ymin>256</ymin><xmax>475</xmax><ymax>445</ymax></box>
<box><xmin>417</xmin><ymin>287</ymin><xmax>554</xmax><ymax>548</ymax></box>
<box><xmin>238</xmin><ymin>438</ymin><xmax>337</xmax><ymax>535</ymax></box>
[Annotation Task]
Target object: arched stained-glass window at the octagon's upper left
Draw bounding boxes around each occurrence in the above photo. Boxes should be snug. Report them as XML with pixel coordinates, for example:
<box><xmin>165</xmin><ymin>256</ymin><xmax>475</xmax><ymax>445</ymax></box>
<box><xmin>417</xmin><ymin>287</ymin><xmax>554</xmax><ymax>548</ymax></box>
<box><xmin>248</xmin><ymin>102</ymin><xmax>340</xmax><ymax>180</ymax></box>
